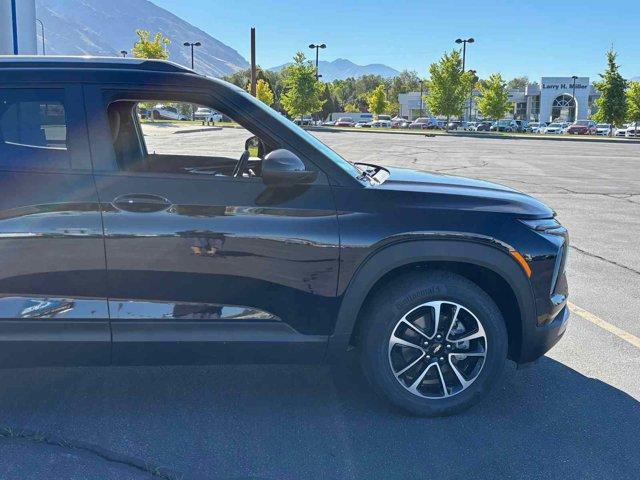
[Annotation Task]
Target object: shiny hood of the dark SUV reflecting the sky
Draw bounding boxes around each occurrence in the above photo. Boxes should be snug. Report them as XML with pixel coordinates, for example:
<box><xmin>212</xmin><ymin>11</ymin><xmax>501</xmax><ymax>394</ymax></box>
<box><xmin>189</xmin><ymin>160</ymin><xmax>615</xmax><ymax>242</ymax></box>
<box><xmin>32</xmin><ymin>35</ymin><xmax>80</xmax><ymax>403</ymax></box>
<box><xmin>376</xmin><ymin>168</ymin><xmax>555</xmax><ymax>218</ymax></box>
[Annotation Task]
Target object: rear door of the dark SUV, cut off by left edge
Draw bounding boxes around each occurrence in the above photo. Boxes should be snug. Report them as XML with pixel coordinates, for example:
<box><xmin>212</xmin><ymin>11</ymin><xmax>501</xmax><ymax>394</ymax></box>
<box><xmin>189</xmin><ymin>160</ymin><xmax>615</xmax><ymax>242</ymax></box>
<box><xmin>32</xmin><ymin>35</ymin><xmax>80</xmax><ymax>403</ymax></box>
<box><xmin>0</xmin><ymin>84</ymin><xmax>111</xmax><ymax>367</ymax></box>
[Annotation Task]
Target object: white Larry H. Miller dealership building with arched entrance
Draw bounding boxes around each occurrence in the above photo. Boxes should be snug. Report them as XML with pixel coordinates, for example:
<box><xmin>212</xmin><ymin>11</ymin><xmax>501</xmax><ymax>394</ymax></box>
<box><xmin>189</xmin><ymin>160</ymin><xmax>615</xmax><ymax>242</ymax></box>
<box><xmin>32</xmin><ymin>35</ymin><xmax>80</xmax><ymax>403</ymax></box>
<box><xmin>398</xmin><ymin>77</ymin><xmax>598</xmax><ymax>122</ymax></box>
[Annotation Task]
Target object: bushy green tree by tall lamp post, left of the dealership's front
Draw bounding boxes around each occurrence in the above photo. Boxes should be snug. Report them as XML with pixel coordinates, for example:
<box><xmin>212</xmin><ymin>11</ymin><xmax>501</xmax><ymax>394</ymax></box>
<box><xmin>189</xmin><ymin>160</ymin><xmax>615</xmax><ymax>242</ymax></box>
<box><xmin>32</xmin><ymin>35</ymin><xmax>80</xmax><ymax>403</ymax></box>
<box><xmin>426</xmin><ymin>50</ymin><xmax>474</xmax><ymax>125</ymax></box>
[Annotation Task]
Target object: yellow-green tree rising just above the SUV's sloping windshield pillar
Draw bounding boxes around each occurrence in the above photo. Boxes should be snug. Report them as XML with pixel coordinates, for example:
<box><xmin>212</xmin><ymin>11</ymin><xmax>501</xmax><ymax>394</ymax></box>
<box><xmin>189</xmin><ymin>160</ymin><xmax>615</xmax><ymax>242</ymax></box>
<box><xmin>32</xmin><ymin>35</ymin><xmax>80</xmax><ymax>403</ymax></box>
<box><xmin>281</xmin><ymin>52</ymin><xmax>324</xmax><ymax>117</ymax></box>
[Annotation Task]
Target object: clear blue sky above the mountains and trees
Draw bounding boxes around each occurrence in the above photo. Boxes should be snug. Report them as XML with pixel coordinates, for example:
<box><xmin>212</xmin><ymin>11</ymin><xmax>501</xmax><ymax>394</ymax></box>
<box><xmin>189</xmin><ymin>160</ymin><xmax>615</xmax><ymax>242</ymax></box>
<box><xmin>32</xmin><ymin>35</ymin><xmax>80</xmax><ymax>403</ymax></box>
<box><xmin>152</xmin><ymin>0</ymin><xmax>640</xmax><ymax>80</ymax></box>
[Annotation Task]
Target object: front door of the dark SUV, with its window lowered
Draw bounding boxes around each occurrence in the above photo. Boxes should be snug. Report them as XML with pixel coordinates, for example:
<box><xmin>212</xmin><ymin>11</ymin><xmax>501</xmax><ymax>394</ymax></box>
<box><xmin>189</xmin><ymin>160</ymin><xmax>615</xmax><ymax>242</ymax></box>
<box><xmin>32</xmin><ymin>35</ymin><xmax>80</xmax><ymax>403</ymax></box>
<box><xmin>87</xmin><ymin>88</ymin><xmax>339</xmax><ymax>364</ymax></box>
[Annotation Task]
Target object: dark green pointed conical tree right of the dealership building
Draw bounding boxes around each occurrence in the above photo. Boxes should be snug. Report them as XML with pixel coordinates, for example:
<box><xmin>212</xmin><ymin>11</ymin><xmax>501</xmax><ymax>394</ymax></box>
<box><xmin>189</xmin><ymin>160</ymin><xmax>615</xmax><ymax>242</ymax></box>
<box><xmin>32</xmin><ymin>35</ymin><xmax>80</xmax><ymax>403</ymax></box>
<box><xmin>592</xmin><ymin>49</ymin><xmax>627</xmax><ymax>125</ymax></box>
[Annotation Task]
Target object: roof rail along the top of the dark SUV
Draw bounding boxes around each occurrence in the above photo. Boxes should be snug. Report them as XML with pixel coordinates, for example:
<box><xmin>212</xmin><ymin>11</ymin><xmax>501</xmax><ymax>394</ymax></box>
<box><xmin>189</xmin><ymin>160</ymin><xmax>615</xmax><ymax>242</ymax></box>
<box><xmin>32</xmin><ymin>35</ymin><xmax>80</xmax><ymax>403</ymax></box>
<box><xmin>0</xmin><ymin>55</ymin><xmax>195</xmax><ymax>74</ymax></box>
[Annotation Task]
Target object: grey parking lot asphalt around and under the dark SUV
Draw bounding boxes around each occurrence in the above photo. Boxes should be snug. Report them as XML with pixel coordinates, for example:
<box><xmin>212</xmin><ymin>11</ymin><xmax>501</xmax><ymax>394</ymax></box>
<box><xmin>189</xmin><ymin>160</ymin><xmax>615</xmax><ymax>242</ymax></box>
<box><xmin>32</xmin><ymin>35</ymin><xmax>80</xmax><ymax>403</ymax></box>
<box><xmin>0</xmin><ymin>129</ymin><xmax>640</xmax><ymax>480</ymax></box>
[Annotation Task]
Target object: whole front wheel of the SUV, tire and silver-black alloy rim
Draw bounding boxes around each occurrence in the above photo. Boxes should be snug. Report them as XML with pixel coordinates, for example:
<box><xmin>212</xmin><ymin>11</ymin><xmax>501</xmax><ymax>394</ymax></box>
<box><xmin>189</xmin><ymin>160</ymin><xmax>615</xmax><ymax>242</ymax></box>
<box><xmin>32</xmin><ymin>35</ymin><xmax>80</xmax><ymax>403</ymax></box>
<box><xmin>360</xmin><ymin>271</ymin><xmax>507</xmax><ymax>416</ymax></box>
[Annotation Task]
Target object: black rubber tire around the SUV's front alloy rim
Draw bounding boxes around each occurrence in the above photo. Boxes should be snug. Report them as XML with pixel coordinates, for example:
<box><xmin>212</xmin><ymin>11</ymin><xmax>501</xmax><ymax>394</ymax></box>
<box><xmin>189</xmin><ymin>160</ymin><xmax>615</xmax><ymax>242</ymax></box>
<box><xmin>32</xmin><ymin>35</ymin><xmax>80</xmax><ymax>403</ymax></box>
<box><xmin>360</xmin><ymin>271</ymin><xmax>508</xmax><ymax>417</ymax></box>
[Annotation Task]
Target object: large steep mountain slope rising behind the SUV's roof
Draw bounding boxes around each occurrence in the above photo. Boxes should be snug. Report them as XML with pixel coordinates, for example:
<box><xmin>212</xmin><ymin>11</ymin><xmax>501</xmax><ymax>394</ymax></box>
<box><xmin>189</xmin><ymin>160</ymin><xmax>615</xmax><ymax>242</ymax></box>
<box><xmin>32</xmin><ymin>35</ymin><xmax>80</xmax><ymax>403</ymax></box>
<box><xmin>36</xmin><ymin>0</ymin><xmax>249</xmax><ymax>77</ymax></box>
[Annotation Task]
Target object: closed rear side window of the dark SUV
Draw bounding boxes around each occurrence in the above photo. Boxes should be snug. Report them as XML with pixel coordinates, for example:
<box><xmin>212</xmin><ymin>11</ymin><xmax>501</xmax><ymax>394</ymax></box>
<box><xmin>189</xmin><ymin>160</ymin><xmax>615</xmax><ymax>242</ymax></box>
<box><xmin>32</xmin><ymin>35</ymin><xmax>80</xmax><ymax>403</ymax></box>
<box><xmin>0</xmin><ymin>88</ymin><xmax>70</xmax><ymax>170</ymax></box>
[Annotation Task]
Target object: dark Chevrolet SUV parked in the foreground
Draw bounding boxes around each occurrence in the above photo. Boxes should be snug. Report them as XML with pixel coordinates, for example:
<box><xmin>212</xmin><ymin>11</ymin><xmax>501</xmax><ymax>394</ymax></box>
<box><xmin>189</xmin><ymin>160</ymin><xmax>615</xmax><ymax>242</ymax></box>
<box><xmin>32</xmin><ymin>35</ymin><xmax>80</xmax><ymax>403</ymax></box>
<box><xmin>0</xmin><ymin>57</ymin><xmax>568</xmax><ymax>415</ymax></box>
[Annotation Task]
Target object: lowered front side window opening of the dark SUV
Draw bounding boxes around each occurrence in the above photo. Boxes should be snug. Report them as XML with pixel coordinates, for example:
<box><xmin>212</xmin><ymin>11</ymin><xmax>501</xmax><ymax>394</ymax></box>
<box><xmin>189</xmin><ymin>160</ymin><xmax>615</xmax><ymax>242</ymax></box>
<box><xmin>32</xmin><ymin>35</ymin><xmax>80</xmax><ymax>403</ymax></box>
<box><xmin>107</xmin><ymin>100</ymin><xmax>270</xmax><ymax>178</ymax></box>
